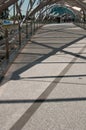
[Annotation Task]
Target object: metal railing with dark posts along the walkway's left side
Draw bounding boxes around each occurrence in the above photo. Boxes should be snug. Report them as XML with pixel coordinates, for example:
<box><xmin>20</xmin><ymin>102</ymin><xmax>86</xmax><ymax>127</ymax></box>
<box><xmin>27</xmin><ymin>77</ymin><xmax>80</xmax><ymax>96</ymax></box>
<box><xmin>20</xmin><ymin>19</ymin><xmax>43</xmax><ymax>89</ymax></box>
<box><xmin>0</xmin><ymin>20</ymin><xmax>42</xmax><ymax>79</ymax></box>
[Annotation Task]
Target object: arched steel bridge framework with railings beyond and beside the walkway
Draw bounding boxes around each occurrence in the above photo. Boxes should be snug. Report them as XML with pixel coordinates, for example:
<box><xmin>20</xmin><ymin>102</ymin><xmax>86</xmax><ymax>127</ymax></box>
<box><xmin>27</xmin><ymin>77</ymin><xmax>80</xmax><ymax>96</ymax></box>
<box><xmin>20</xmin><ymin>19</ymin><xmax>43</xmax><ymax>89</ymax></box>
<box><xmin>0</xmin><ymin>0</ymin><xmax>86</xmax><ymax>78</ymax></box>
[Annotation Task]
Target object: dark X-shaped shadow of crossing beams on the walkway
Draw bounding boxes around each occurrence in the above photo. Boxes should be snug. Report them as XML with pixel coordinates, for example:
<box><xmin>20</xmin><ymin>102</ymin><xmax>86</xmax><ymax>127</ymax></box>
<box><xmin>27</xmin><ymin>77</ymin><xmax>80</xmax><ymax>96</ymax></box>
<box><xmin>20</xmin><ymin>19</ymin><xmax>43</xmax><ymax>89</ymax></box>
<box><xmin>2</xmin><ymin>24</ymin><xmax>86</xmax><ymax>84</ymax></box>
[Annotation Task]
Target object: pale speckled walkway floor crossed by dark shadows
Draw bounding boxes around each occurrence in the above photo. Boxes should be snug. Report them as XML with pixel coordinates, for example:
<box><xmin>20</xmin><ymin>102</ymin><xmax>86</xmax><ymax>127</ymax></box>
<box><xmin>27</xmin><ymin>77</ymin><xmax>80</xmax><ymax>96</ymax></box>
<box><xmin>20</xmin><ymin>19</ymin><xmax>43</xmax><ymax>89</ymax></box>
<box><xmin>0</xmin><ymin>23</ymin><xmax>86</xmax><ymax>130</ymax></box>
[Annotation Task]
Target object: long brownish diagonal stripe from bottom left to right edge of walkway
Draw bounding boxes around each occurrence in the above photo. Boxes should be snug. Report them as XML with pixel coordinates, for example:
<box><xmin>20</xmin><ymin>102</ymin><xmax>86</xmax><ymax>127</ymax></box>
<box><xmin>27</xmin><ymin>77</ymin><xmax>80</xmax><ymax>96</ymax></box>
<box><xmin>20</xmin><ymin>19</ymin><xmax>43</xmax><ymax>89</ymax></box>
<box><xmin>10</xmin><ymin>39</ymin><xmax>86</xmax><ymax>130</ymax></box>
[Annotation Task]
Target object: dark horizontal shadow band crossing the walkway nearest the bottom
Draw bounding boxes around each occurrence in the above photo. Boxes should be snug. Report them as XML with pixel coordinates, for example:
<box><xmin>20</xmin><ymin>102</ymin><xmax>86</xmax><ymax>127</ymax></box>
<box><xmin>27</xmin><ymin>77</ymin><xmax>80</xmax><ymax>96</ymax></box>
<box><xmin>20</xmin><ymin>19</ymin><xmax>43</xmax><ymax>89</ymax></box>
<box><xmin>0</xmin><ymin>97</ymin><xmax>86</xmax><ymax>104</ymax></box>
